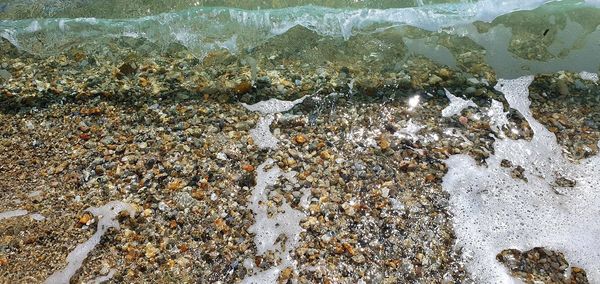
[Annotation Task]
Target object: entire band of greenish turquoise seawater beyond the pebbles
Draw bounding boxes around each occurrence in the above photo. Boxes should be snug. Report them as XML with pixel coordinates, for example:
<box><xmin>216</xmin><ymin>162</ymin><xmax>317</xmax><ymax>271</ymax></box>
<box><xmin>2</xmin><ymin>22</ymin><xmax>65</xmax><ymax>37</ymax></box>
<box><xmin>0</xmin><ymin>1</ymin><xmax>600</xmax><ymax>77</ymax></box>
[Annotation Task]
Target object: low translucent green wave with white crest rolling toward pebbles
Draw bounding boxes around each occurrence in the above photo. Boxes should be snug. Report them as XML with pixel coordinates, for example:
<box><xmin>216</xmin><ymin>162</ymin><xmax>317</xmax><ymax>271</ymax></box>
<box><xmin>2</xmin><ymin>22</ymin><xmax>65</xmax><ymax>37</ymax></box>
<box><xmin>0</xmin><ymin>0</ymin><xmax>600</xmax><ymax>77</ymax></box>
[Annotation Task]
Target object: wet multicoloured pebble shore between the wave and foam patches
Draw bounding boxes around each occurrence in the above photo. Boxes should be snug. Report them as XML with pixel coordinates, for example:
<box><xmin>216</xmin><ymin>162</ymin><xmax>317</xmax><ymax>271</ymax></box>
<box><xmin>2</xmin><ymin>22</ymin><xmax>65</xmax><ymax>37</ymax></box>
<box><xmin>0</xmin><ymin>36</ymin><xmax>600</xmax><ymax>283</ymax></box>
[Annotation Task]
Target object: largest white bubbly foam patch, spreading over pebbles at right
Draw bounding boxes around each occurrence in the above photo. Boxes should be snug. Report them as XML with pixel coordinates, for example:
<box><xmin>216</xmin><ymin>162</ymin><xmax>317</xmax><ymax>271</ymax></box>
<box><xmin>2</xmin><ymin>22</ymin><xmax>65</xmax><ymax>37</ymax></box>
<box><xmin>442</xmin><ymin>76</ymin><xmax>600</xmax><ymax>283</ymax></box>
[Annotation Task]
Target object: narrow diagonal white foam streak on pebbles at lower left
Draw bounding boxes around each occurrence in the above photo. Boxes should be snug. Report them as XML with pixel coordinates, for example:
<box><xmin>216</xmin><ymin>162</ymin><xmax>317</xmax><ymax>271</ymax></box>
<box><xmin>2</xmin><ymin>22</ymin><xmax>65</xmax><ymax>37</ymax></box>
<box><xmin>44</xmin><ymin>201</ymin><xmax>135</xmax><ymax>284</ymax></box>
